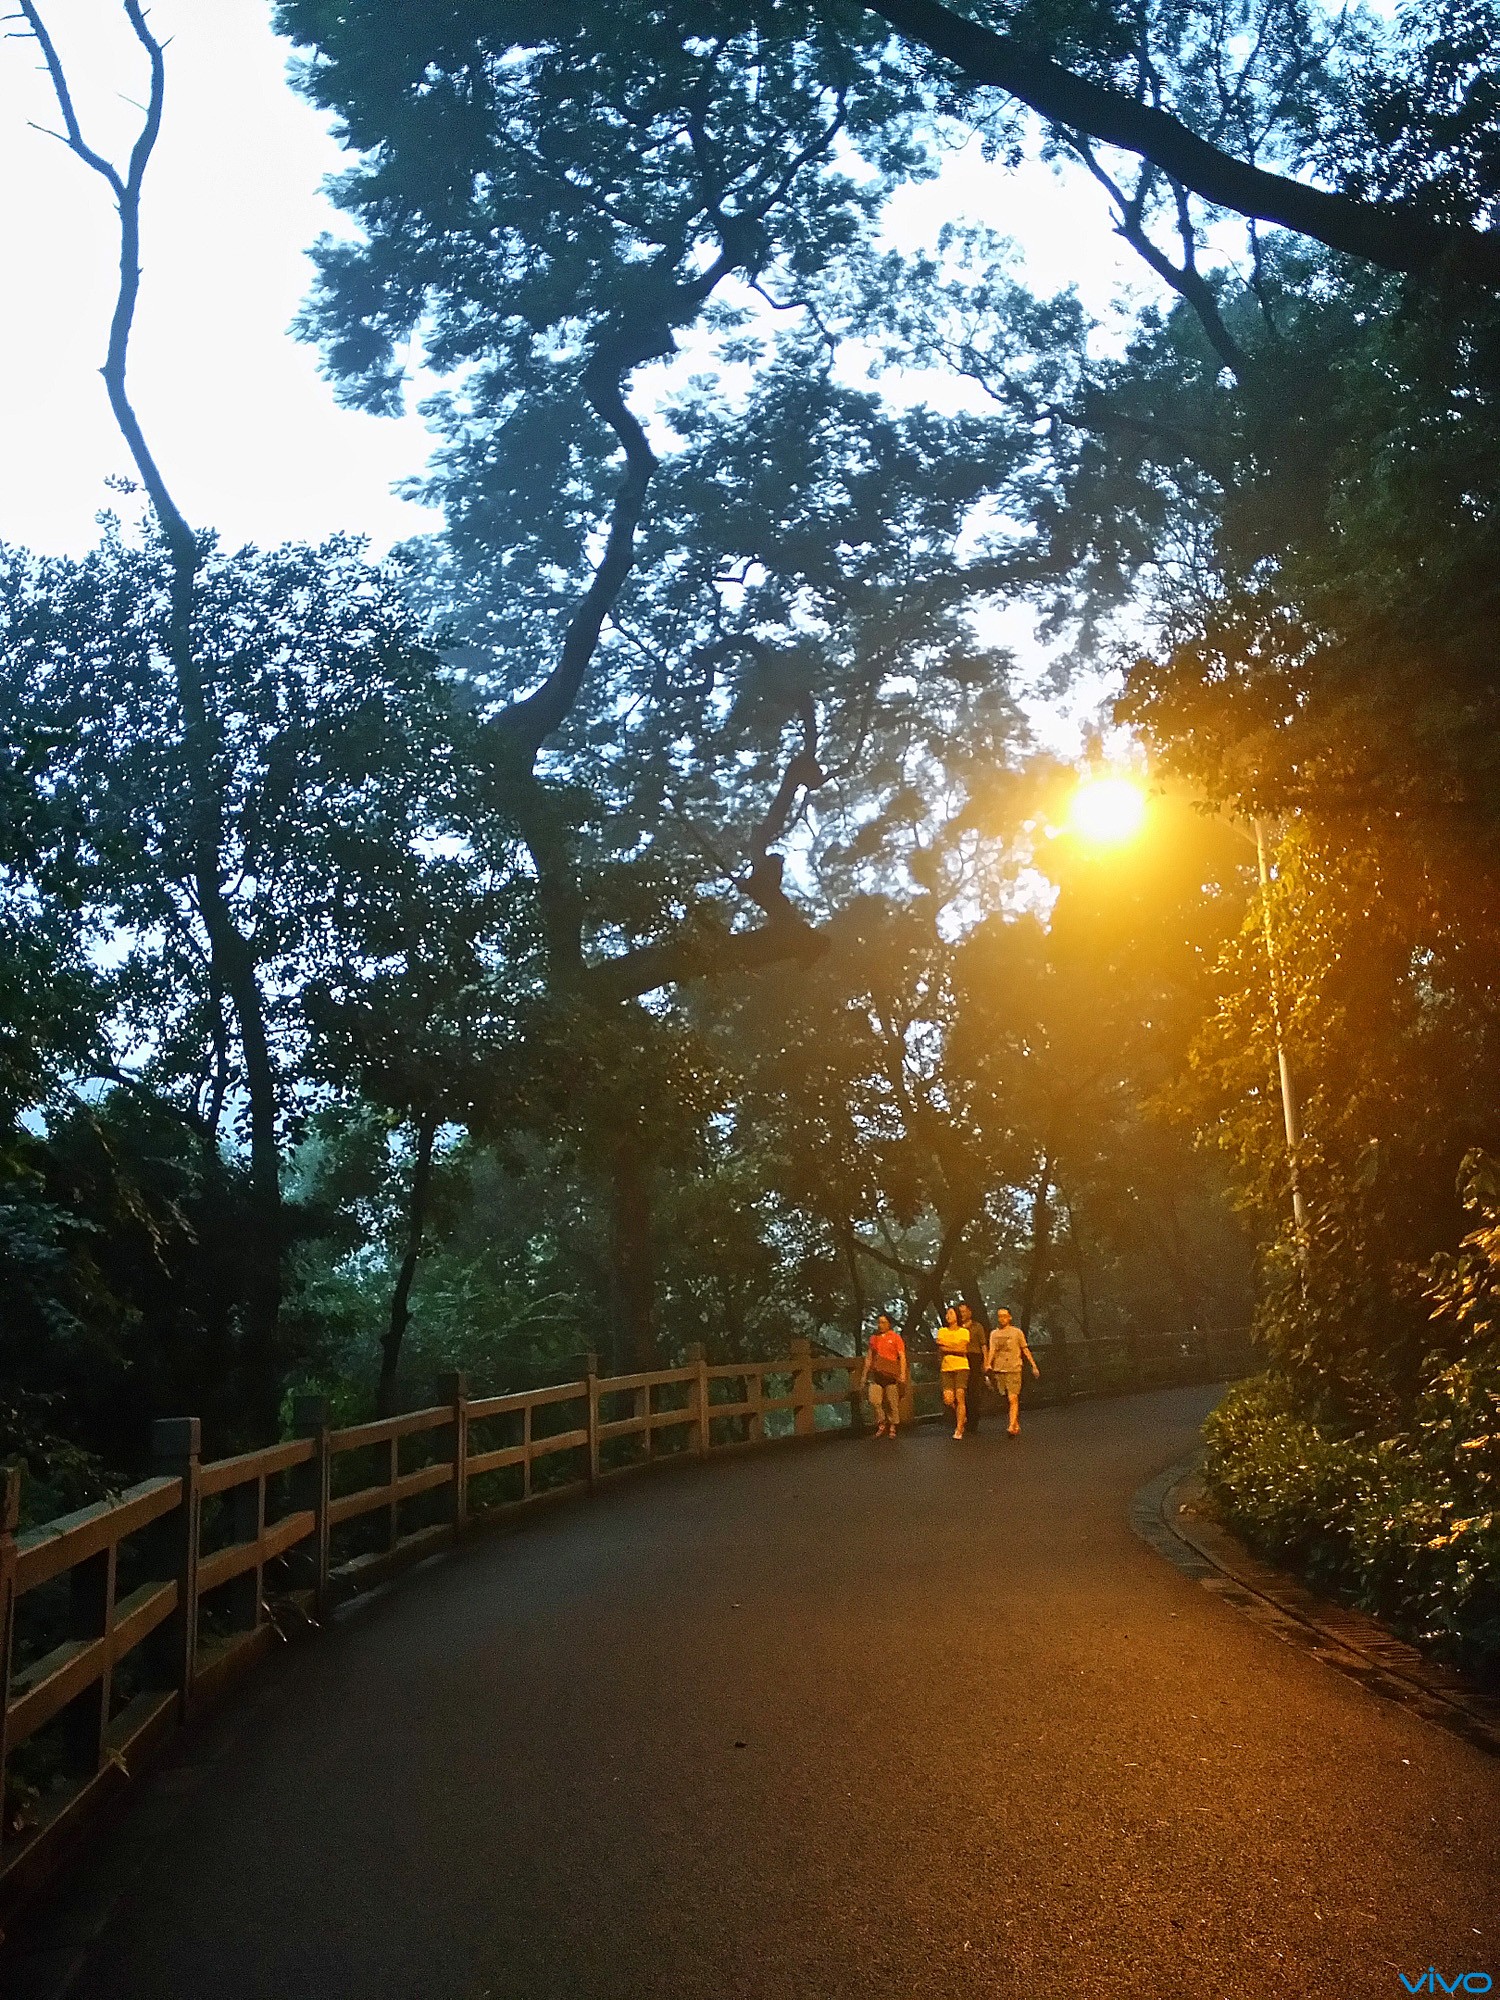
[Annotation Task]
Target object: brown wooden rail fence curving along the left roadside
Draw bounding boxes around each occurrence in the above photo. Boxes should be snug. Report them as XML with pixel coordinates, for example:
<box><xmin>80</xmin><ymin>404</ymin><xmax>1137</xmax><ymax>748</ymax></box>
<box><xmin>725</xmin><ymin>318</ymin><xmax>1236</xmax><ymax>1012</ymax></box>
<box><xmin>0</xmin><ymin>1338</ymin><xmax>1244</xmax><ymax>1924</ymax></box>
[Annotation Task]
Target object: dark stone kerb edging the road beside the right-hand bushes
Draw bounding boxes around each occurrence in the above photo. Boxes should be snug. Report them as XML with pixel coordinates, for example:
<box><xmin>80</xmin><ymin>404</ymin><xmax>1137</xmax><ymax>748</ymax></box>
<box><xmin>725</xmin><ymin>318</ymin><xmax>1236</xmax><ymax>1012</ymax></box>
<box><xmin>1130</xmin><ymin>1462</ymin><xmax>1500</xmax><ymax>1756</ymax></box>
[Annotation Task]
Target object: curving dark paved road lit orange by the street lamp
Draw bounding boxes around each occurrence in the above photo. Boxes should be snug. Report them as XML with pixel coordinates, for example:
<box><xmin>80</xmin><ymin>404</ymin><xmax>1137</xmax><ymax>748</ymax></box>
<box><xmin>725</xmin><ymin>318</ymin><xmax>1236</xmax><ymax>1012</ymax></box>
<box><xmin>12</xmin><ymin>1390</ymin><xmax>1500</xmax><ymax>2000</ymax></box>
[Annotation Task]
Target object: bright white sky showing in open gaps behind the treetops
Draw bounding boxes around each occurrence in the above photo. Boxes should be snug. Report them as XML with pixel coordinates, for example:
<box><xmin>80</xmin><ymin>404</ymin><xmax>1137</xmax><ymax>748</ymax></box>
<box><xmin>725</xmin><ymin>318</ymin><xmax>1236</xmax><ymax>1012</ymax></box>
<box><xmin>0</xmin><ymin>0</ymin><xmax>1140</xmax><ymax>554</ymax></box>
